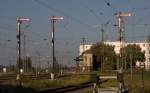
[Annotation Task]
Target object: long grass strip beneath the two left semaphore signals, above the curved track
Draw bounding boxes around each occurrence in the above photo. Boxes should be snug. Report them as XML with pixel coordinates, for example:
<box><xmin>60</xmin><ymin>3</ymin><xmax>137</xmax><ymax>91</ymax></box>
<box><xmin>4</xmin><ymin>75</ymin><xmax>89</xmax><ymax>93</ymax></box>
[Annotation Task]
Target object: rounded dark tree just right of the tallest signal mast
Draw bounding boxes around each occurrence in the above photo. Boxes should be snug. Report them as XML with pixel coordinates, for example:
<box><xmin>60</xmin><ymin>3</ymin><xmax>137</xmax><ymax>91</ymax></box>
<box><xmin>124</xmin><ymin>44</ymin><xmax>145</xmax><ymax>68</ymax></box>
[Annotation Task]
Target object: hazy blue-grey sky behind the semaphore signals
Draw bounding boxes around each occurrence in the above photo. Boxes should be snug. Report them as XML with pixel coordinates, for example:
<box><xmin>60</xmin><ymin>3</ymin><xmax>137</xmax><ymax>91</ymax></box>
<box><xmin>0</xmin><ymin>0</ymin><xmax>150</xmax><ymax>66</ymax></box>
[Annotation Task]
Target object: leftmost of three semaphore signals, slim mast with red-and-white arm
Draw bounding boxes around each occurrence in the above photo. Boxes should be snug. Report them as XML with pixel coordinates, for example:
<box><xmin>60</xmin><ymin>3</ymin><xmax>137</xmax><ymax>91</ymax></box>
<box><xmin>16</xmin><ymin>17</ymin><xmax>30</xmax><ymax>85</ymax></box>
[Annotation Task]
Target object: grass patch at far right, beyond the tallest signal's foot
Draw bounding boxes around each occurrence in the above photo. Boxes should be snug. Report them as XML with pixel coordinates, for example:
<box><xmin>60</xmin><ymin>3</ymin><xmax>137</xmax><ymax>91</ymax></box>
<box><xmin>124</xmin><ymin>72</ymin><xmax>150</xmax><ymax>93</ymax></box>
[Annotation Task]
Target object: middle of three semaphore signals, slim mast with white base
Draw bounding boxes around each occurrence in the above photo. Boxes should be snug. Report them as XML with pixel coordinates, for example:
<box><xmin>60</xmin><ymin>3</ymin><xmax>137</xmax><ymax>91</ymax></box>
<box><xmin>50</xmin><ymin>16</ymin><xmax>64</xmax><ymax>79</ymax></box>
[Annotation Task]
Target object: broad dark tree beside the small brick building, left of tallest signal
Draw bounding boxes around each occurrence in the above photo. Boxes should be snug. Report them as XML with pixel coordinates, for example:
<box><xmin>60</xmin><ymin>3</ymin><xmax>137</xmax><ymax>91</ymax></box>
<box><xmin>90</xmin><ymin>43</ymin><xmax>116</xmax><ymax>70</ymax></box>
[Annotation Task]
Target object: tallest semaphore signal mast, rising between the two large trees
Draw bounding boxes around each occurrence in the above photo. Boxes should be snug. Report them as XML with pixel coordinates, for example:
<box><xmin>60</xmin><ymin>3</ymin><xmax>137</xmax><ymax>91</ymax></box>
<box><xmin>115</xmin><ymin>12</ymin><xmax>131</xmax><ymax>68</ymax></box>
